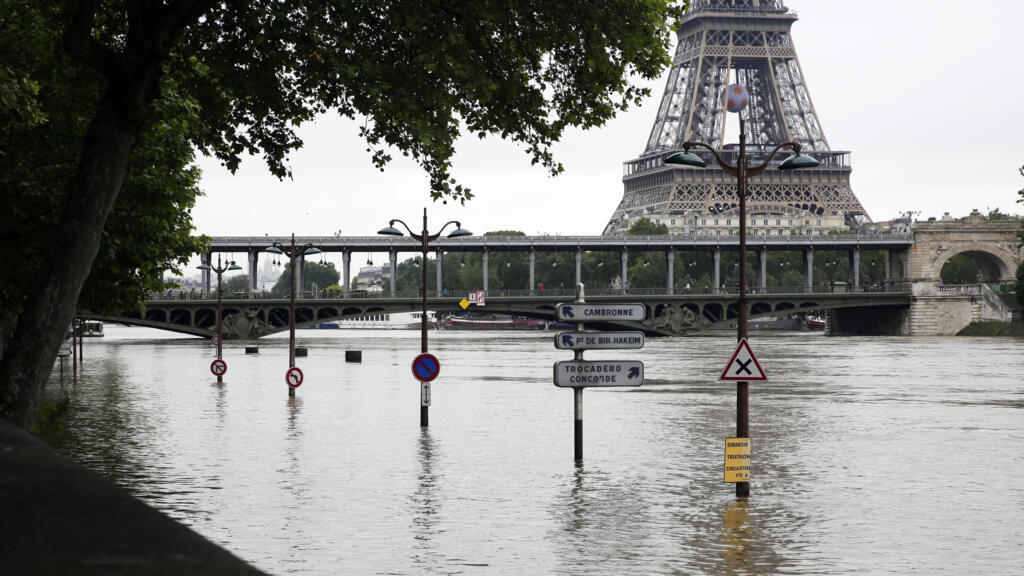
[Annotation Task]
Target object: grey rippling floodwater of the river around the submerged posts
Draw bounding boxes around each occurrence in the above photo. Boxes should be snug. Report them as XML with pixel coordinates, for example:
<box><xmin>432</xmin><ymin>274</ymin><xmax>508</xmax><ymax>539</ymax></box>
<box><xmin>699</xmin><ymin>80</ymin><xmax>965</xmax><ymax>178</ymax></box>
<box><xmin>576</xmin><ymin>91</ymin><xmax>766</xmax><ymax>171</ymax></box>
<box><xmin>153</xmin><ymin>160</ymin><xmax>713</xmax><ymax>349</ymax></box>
<box><xmin>48</xmin><ymin>326</ymin><xmax>1024</xmax><ymax>575</ymax></box>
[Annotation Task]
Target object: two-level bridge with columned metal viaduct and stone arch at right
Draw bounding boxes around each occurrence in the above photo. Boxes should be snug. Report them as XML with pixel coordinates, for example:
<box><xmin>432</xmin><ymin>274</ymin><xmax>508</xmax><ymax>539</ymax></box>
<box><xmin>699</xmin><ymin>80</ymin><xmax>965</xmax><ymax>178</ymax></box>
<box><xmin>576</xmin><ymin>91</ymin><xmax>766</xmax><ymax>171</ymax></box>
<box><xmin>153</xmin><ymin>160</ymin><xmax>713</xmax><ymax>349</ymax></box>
<box><xmin>90</xmin><ymin>210</ymin><xmax>1022</xmax><ymax>338</ymax></box>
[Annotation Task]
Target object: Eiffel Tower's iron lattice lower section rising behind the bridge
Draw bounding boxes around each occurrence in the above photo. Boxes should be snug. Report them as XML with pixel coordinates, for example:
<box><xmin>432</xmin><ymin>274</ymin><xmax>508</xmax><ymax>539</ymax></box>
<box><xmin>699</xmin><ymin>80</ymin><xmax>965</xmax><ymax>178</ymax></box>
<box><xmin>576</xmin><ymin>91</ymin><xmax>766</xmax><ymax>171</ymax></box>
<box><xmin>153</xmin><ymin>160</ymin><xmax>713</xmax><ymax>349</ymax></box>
<box><xmin>604</xmin><ymin>0</ymin><xmax>870</xmax><ymax>236</ymax></box>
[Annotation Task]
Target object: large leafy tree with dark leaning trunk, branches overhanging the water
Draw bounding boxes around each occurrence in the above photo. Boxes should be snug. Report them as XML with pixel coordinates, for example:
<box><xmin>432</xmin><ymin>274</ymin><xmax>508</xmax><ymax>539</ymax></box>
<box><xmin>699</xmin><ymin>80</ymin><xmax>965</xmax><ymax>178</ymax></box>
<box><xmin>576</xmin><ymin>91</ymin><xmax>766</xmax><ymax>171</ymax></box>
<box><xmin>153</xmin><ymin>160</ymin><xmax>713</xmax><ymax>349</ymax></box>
<box><xmin>0</xmin><ymin>0</ymin><xmax>683</xmax><ymax>426</ymax></box>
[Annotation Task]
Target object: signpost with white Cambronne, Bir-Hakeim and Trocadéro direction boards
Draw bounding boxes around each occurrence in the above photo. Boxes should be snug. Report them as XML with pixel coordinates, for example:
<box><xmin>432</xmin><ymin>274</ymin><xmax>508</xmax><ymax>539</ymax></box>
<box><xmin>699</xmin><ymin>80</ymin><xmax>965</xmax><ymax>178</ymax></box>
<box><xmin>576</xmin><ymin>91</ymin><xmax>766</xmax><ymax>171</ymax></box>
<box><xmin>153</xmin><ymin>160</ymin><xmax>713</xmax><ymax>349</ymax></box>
<box><xmin>554</xmin><ymin>283</ymin><xmax>647</xmax><ymax>461</ymax></box>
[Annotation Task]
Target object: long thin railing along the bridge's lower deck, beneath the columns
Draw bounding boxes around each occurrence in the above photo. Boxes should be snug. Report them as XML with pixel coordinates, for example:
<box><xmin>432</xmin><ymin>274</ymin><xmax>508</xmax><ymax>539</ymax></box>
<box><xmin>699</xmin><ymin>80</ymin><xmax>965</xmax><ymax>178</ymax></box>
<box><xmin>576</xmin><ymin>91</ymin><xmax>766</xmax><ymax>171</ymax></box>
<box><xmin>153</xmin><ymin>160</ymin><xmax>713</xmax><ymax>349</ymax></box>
<box><xmin>148</xmin><ymin>282</ymin><xmax>913</xmax><ymax>301</ymax></box>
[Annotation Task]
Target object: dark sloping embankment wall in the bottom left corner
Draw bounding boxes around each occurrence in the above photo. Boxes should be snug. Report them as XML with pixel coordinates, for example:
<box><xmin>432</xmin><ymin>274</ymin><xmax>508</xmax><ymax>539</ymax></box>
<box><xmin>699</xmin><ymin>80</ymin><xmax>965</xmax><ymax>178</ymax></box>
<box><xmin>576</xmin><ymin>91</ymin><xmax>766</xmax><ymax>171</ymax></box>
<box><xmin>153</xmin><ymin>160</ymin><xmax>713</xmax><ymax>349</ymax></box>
<box><xmin>0</xmin><ymin>419</ymin><xmax>262</xmax><ymax>575</ymax></box>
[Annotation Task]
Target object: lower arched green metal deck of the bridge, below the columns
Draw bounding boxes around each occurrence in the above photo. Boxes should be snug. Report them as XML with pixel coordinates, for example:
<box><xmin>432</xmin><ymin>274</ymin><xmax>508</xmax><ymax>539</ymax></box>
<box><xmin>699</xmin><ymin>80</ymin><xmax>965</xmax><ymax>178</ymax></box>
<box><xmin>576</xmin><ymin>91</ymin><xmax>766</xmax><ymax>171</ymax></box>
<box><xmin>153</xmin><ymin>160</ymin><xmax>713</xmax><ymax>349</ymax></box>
<box><xmin>89</xmin><ymin>283</ymin><xmax>911</xmax><ymax>339</ymax></box>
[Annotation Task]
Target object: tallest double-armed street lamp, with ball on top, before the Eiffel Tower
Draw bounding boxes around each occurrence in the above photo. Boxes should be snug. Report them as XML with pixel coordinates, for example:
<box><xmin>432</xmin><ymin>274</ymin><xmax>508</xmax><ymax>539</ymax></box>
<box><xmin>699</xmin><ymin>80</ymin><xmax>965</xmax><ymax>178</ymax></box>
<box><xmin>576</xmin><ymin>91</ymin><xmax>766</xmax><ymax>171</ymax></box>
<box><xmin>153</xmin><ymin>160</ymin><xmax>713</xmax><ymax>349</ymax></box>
<box><xmin>665</xmin><ymin>84</ymin><xmax>818</xmax><ymax>497</ymax></box>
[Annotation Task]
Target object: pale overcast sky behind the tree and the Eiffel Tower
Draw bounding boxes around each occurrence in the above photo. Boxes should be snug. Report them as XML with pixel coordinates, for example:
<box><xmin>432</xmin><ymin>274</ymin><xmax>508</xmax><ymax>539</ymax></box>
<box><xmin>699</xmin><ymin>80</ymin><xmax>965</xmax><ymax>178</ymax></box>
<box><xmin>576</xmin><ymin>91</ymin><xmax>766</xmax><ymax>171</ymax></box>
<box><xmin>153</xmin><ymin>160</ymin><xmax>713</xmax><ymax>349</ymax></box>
<box><xmin>193</xmin><ymin>0</ymin><xmax>1024</xmax><ymax>242</ymax></box>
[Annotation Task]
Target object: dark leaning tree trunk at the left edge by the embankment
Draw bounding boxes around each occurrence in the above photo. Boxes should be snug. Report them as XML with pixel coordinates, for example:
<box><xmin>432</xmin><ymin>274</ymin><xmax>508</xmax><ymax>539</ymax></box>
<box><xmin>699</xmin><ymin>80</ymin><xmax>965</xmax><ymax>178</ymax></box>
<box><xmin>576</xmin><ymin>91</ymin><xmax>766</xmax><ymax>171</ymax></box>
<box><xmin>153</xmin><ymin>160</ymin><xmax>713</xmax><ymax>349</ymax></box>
<box><xmin>0</xmin><ymin>84</ymin><xmax>149</xmax><ymax>428</ymax></box>
